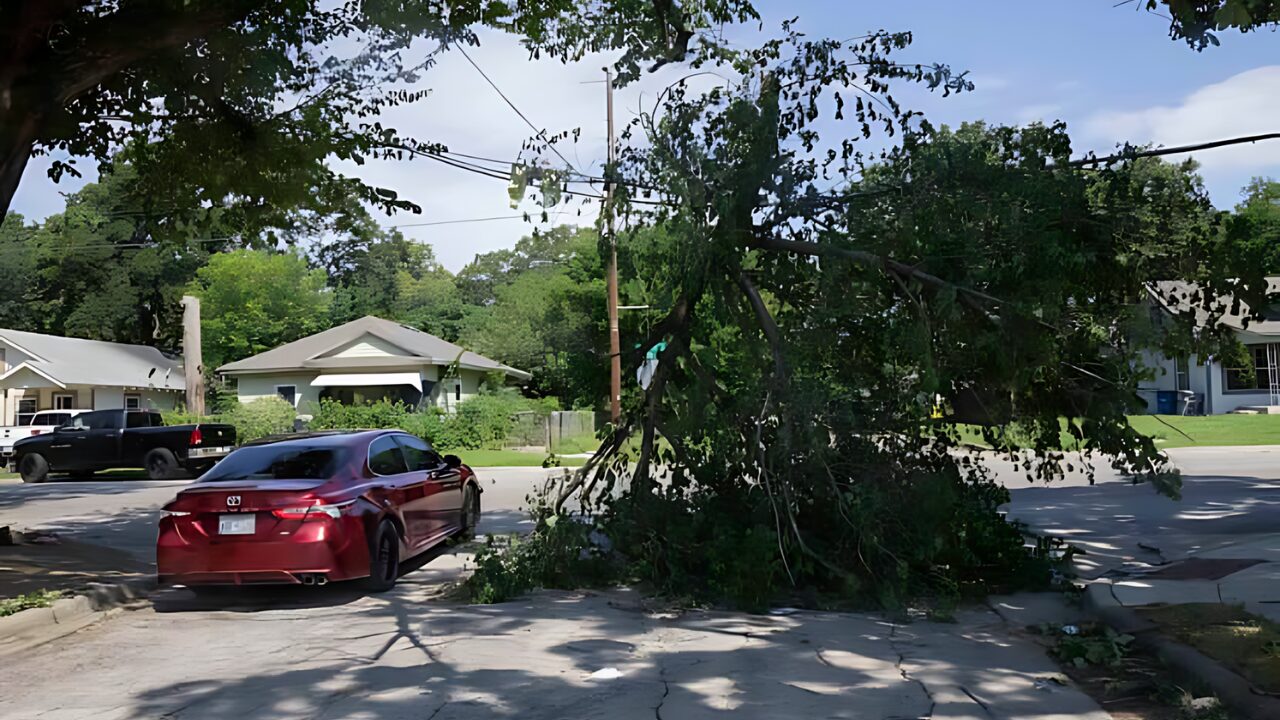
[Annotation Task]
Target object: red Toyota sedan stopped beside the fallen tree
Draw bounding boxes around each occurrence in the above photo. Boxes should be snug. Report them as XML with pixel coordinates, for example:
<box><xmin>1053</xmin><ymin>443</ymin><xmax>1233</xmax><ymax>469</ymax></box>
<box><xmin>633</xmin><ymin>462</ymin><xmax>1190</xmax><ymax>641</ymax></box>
<box><xmin>156</xmin><ymin>430</ymin><xmax>480</xmax><ymax>592</ymax></box>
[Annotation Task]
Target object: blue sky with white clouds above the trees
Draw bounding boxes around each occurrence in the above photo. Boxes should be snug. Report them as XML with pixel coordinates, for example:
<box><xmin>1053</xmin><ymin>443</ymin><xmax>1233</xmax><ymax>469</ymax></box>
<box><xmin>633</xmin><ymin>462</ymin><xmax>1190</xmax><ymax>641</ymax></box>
<box><xmin>13</xmin><ymin>0</ymin><xmax>1280</xmax><ymax>270</ymax></box>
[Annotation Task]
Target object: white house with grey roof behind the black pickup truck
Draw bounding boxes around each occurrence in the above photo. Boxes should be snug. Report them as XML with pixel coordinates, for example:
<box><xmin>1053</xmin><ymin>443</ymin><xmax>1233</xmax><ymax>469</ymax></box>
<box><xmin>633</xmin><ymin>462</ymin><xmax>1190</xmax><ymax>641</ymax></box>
<box><xmin>0</xmin><ymin>329</ymin><xmax>186</xmax><ymax>425</ymax></box>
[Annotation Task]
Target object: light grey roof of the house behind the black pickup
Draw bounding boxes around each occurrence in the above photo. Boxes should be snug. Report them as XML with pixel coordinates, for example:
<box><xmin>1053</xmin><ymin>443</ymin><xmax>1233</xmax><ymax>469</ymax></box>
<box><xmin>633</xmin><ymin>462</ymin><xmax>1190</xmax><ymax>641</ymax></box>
<box><xmin>0</xmin><ymin>328</ymin><xmax>186</xmax><ymax>389</ymax></box>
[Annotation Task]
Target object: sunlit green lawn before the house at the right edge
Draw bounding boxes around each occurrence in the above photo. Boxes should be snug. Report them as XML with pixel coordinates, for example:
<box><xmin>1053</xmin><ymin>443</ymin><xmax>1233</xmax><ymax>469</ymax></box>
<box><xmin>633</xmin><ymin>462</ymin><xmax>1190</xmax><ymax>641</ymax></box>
<box><xmin>957</xmin><ymin>415</ymin><xmax>1280</xmax><ymax>448</ymax></box>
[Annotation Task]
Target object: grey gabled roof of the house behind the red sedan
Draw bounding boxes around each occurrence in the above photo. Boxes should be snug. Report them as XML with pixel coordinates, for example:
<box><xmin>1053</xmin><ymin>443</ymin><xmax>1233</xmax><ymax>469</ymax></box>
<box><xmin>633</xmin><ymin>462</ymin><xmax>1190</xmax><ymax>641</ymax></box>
<box><xmin>218</xmin><ymin>315</ymin><xmax>532</xmax><ymax>380</ymax></box>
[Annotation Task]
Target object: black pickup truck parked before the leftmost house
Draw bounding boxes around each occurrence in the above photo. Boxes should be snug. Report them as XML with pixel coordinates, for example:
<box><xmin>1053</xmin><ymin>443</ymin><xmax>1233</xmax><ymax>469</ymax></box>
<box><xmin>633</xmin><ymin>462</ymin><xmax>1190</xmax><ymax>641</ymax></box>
<box><xmin>13</xmin><ymin>410</ymin><xmax>236</xmax><ymax>483</ymax></box>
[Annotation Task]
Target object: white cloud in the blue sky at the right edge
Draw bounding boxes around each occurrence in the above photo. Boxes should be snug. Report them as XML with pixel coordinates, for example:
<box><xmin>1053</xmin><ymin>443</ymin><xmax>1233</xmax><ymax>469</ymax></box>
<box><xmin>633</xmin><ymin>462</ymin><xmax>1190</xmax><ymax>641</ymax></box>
<box><xmin>1083</xmin><ymin>65</ymin><xmax>1280</xmax><ymax>170</ymax></box>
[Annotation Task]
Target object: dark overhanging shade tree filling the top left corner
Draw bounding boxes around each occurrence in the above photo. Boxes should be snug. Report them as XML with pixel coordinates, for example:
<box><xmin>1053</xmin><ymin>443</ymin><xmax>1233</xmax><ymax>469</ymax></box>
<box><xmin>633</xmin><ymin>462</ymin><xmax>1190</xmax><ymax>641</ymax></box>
<box><xmin>0</xmin><ymin>0</ymin><xmax>754</xmax><ymax>227</ymax></box>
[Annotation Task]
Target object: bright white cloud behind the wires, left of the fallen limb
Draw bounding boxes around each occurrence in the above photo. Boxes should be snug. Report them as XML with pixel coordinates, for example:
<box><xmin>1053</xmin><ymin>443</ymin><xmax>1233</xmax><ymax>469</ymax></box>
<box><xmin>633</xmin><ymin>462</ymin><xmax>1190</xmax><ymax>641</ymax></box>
<box><xmin>13</xmin><ymin>28</ymin><xmax>714</xmax><ymax>272</ymax></box>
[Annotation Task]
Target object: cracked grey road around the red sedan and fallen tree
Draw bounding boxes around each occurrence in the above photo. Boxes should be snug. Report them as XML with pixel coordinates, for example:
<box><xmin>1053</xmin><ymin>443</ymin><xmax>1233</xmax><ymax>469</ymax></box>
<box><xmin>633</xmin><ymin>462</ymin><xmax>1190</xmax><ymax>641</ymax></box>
<box><xmin>0</xmin><ymin>448</ymin><xmax>1280</xmax><ymax>720</ymax></box>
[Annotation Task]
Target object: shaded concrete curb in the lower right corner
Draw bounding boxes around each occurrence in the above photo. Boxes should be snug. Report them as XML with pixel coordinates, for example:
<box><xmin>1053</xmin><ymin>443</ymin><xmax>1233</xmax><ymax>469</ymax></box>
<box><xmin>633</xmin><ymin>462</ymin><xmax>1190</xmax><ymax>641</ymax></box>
<box><xmin>1083</xmin><ymin>583</ymin><xmax>1280</xmax><ymax>720</ymax></box>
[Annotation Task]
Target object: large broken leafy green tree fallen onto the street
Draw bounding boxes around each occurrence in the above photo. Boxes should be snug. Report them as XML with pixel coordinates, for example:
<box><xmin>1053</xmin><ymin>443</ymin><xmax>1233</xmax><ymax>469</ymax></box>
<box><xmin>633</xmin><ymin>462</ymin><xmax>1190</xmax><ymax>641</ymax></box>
<box><xmin>532</xmin><ymin>25</ymin><xmax>1267</xmax><ymax>603</ymax></box>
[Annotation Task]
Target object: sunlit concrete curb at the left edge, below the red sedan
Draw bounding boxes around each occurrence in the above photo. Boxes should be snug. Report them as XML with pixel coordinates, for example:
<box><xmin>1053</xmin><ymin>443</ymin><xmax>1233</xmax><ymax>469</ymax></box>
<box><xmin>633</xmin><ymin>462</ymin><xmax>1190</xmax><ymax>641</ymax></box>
<box><xmin>0</xmin><ymin>575</ymin><xmax>156</xmax><ymax>655</ymax></box>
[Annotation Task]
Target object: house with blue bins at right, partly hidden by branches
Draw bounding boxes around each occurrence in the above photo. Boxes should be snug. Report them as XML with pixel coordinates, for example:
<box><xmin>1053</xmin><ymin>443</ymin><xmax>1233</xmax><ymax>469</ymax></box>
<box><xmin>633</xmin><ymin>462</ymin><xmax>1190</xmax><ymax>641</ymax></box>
<box><xmin>1140</xmin><ymin>278</ymin><xmax>1280</xmax><ymax>415</ymax></box>
